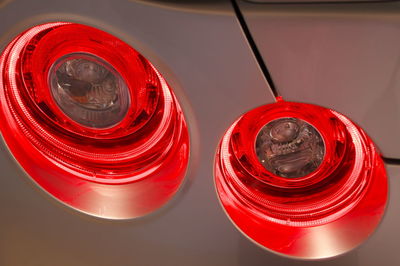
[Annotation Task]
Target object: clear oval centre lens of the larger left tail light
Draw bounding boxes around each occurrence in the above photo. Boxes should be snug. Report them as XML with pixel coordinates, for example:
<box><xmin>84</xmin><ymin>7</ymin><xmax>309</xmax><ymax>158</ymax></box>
<box><xmin>49</xmin><ymin>53</ymin><xmax>130</xmax><ymax>128</ymax></box>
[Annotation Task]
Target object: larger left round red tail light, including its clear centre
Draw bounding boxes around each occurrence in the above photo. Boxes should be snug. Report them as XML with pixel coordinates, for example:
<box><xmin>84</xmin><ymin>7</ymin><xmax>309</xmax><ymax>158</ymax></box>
<box><xmin>0</xmin><ymin>22</ymin><xmax>189</xmax><ymax>219</ymax></box>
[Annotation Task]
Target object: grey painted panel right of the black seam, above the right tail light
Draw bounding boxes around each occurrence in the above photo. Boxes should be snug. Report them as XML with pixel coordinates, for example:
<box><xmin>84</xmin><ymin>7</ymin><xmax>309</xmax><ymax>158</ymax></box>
<box><xmin>238</xmin><ymin>0</ymin><xmax>400</xmax><ymax>158</ymax></box>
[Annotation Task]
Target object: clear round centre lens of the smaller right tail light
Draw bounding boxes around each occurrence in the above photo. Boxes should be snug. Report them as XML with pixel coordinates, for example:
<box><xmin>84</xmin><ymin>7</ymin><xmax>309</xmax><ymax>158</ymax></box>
<box><xmin>256</xmin><ymin>118</ymin><xmax>325</xmax><ymax>178</ymax></box>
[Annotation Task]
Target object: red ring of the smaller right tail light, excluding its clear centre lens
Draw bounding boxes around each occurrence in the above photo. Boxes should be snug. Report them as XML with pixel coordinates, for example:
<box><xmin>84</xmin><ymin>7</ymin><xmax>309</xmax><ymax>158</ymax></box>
<box><xmin>214</xmin><ymin>101</ymin><xmax>388</xmax><ymax>259</ymax></box>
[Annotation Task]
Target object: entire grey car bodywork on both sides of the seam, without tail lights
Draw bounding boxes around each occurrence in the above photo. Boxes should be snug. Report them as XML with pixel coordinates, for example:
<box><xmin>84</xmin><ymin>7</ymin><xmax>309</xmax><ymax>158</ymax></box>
<box><xmin>0</xmin><ymin>0</ymin><xmax>400</xmax><ymax>266</ymax></box>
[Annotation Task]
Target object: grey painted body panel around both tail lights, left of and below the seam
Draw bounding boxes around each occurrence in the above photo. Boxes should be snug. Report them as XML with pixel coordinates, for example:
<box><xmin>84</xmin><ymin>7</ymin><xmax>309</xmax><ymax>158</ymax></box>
<box><xmin>0</xmin><ymin>0</ymin><xmax>400</xmax><ymax>266</ymax></box>
